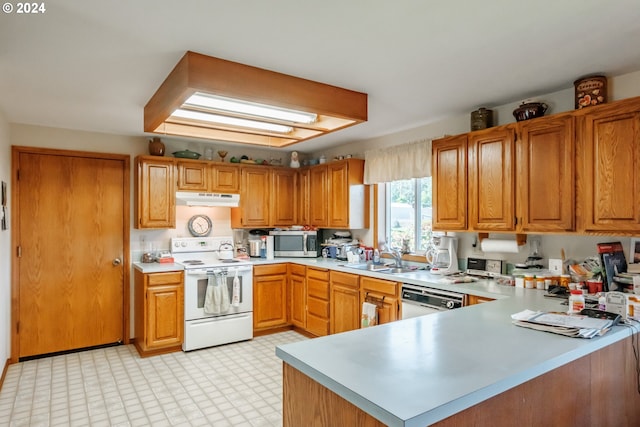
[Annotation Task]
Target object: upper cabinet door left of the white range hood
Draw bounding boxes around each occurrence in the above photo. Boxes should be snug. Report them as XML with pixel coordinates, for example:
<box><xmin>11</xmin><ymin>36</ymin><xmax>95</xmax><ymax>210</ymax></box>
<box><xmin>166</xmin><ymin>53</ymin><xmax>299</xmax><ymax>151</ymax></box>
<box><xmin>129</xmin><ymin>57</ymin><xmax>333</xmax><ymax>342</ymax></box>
<box><xmin>135</xmin><ymin>158</ymin><xmax>176</xmax><ymax>228</ymax></box>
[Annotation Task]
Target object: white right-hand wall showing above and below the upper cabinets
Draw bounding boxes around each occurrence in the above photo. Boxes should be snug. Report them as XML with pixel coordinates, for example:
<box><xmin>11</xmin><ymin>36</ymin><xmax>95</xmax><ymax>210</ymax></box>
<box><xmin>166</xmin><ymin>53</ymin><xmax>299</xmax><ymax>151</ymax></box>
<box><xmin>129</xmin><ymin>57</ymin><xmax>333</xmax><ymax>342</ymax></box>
<box><xmin>313</xmin><ymin>71</ymin><xmax>640</xmax><ymax>263</ymax></box>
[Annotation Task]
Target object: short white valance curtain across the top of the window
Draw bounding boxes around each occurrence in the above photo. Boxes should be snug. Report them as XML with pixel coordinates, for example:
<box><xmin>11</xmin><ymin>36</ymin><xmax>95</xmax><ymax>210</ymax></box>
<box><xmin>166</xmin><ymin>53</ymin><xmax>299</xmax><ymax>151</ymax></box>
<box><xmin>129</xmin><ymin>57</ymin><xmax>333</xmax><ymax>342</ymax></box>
<box><xmin>364</xmin><ymin>139</ymin><xmax>431</xmax><ymax>184</ymax></box>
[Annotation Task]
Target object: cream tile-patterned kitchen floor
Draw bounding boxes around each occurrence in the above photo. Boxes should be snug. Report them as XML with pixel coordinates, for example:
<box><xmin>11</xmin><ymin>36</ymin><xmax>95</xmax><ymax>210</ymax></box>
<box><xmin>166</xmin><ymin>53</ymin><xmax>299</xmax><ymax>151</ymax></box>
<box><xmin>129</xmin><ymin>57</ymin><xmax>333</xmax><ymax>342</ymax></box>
<box><xmin>0</xmin><ymin>331</ymin><xmax>307</xmax><ymax>427</ymax></box>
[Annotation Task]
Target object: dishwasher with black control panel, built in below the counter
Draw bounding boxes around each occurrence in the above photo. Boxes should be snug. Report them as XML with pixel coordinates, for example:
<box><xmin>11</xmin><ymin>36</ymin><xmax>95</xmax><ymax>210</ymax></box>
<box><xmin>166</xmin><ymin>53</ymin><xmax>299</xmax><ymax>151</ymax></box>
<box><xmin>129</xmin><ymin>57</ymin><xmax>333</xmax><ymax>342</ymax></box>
<box><xmin>402</xmin><ymin>283</ymin><xmax>465</xmax><ymax>319</ymax></box>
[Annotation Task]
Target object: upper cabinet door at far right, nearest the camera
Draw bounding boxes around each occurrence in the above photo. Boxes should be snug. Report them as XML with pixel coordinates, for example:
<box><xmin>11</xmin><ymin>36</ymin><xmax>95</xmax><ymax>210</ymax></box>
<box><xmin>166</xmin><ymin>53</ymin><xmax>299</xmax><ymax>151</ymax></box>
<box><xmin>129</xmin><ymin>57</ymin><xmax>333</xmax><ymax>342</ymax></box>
<box><xmin>578</xmin><ymin>98</ymin><xmax>640</xmax><ymax>232</ymax></box>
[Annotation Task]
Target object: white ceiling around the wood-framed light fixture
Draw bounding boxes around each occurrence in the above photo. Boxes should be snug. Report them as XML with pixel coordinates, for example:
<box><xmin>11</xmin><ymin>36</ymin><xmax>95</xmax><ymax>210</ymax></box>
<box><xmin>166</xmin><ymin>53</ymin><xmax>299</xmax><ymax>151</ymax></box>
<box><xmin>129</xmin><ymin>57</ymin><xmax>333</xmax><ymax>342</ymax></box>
<box><xmin>0</xmin><ymin>0</ymin><xmax>640</xmax><ymax>152</ymax></box>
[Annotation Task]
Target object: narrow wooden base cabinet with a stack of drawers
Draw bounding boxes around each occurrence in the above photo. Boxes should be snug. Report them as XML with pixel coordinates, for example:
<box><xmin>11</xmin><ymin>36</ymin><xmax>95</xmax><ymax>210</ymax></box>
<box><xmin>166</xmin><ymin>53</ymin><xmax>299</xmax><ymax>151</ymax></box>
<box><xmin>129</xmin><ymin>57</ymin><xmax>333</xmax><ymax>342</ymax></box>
<box><xmin>307</xmin><ymin>267</ymin><xmax>329</xmax><ymax>336</ymax></box>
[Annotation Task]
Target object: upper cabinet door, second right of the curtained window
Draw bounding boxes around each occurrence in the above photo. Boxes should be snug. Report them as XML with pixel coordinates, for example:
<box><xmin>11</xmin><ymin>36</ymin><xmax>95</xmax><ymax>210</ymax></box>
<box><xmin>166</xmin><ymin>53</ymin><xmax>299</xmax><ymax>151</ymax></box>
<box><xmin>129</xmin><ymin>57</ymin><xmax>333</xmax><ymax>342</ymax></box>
<box><xmin>468</xmin><ymin>127</ymin><xmax>515</xmax><ymax>231</ymax></box>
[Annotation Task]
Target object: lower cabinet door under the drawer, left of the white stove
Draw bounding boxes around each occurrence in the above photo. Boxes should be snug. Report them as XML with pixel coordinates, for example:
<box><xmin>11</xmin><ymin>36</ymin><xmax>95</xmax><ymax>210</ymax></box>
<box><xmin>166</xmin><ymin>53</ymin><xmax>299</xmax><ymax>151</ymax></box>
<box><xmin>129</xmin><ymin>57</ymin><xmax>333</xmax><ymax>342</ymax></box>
<box><xmin>145</xmin><ymin>283</ymin><xmax>184</xmax><ymax>349</ymax></box>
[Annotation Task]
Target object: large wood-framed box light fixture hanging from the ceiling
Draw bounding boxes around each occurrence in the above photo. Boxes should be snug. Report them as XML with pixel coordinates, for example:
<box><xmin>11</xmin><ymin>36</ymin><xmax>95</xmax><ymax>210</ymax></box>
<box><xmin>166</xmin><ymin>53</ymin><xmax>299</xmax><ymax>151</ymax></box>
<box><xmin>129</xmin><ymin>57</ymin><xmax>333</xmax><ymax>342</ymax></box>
<box><xmin>144</xmin><ymin>52</ymin><xmax>368</xmax><ymax>148</ymax></box>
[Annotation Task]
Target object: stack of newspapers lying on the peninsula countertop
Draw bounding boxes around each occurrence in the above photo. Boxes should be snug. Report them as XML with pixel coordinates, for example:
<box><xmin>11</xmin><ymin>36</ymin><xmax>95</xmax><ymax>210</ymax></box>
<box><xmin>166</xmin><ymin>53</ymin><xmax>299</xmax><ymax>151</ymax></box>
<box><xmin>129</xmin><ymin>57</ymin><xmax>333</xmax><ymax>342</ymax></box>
<box><xmin>511</xmin><ymin>310</ymin><xmax>613</xmax><ymax>338</ymax></box>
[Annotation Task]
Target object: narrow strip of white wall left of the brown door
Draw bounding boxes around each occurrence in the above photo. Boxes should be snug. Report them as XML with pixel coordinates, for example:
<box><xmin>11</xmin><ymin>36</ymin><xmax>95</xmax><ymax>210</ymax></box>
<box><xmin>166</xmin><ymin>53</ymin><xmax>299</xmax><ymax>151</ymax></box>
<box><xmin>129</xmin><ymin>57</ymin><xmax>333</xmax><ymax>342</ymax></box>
<box><xmin>0</xmin><ymin>111</ymin><xmax>11</xmax><ymax>366</ymax></box>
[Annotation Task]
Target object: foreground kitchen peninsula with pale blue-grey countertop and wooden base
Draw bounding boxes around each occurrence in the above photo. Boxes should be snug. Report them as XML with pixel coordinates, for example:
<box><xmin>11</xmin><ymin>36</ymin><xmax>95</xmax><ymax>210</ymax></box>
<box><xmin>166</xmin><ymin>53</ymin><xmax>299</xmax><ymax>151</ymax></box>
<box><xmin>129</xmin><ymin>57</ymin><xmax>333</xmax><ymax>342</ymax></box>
<box><xmin>276</xmin><ymin>266</ymin><xmax>640</xmax><ymax>427</ymax></box>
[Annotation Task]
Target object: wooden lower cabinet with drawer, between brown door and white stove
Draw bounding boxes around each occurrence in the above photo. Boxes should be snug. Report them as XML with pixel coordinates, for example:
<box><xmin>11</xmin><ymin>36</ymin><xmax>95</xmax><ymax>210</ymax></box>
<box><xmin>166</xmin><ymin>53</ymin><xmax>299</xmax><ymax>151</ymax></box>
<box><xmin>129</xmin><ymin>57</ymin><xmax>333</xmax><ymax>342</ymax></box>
<box><xmin>134</xmin><ymin>270</ymin><xmax>184</xmax><ymax>357</ymax></box>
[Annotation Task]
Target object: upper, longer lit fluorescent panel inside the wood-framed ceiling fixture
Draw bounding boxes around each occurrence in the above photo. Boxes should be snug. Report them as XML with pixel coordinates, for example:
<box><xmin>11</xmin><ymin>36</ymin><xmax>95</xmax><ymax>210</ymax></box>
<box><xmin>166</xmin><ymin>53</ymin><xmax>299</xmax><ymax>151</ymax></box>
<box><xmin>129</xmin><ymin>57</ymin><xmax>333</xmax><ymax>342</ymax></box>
<box><xmin>183</xmin><ymin>92</ymin><xmax>318</xmax><ymax>124</ymax></box>
